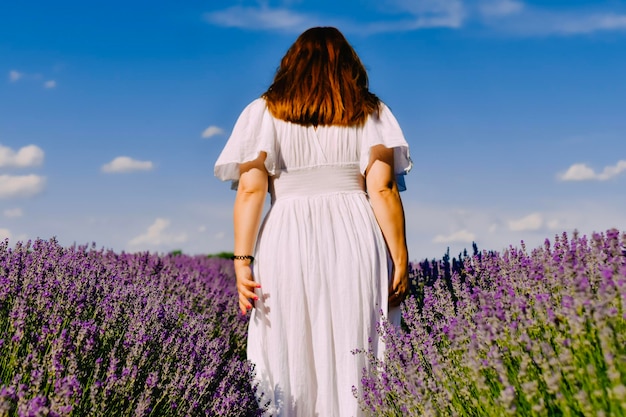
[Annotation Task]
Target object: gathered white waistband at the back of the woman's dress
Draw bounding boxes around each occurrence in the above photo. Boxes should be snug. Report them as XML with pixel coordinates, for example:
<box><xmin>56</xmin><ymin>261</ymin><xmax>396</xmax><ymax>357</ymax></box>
<box><xmin>270</xmin><ymin>166</ymin><xmax>365</xmax><ymax>201</ymax></box>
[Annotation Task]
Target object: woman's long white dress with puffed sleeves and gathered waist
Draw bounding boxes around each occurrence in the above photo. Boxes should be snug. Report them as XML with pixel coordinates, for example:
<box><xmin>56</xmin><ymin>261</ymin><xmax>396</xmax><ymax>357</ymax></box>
<box><xmin>215</xmin><ymin>99</ymin><xmax>411</xmax><ymax>417</ymax></box>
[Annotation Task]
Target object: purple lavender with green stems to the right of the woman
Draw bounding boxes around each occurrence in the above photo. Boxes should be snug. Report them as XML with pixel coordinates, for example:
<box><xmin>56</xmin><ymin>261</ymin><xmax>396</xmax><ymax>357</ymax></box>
<box><xmin>355</xmin><ymin>229</ymin><xmax>626</xmax><ymax>416</ymax></box>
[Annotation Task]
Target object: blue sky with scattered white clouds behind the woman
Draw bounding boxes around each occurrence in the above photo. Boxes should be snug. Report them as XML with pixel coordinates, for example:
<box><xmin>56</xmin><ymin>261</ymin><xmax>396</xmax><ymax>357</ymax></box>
<box><xmin>0</xmin><ymin>0</ymin><xmax>626</xmax><ymax>260</ymax></box>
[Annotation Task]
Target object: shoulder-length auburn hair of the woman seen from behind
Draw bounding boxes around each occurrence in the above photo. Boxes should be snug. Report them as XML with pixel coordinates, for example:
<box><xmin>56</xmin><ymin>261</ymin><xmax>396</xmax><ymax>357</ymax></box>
<box><xmin>263</xmin><ymin>27</ymin><xmax>380</xmax><ymax>126</ymax></box>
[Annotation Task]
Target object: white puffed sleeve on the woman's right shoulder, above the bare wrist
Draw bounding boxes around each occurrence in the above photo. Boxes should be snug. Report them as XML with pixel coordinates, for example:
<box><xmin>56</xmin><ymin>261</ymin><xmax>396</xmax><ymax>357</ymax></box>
<box><xmin>359</xmin><ymin>103</ymin><xmax>413</xmax><ymax>191</ymax></box>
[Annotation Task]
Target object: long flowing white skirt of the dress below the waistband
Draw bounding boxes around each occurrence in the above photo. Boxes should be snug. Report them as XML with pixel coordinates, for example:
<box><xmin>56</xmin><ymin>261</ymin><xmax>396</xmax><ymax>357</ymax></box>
<box><xmin>247</xmin><ymin>190</ymin><xmax>399</xmax><ymax>417</ymax></box>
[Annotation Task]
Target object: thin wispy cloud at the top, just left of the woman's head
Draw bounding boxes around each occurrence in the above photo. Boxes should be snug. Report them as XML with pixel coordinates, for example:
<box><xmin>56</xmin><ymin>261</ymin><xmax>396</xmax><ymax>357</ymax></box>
<box><xmin>204</xmin><ymin>5</ymin><xmax>314</xmax><ymax>31</ymax></box>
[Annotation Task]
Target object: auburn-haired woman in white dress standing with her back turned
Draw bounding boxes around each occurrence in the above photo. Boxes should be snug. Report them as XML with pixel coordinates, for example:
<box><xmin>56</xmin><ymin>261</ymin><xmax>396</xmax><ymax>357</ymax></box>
<box><xmin>215</xmin><ymin>27</ymin><xmax>411</xmax><ymax>417</ymax></box>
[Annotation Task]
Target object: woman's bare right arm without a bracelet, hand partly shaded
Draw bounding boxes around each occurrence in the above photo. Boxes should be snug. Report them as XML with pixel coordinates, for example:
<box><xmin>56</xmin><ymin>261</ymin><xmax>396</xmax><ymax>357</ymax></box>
<box><xmin>365</xmin><ymin>145</ymin><xmax>409</xmax><ymax>307</ymax></box>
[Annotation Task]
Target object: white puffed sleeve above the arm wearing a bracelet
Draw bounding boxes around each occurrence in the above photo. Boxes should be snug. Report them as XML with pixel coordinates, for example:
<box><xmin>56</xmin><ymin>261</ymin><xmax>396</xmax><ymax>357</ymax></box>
<box><xmin>214</xmin><ymin>98</ymin><xmax>276</xmax><ymax>189</ymax></box>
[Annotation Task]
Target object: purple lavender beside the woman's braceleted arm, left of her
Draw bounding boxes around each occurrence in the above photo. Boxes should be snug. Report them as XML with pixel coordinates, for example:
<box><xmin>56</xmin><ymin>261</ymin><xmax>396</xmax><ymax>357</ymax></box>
<box><xmin>0</xmin><ymin>240</ymin><xmax>260</xmax><ymax>416</ymax></box>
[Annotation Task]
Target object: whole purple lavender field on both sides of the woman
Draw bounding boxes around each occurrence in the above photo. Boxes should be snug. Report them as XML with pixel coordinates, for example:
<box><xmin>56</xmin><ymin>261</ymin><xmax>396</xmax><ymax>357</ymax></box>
<box><xmin>0</xmin><ymin>230</ymin><xmax>626</xmax><ymax>417</ymax></box>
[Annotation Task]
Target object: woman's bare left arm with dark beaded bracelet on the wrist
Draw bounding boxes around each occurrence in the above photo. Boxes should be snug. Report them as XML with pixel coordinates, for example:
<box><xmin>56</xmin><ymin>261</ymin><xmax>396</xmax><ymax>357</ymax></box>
<box><xmin>233</xmin><ymin>152</ymin><xmax>268</xmax><ymax>314</ymax></box>
